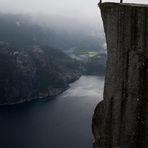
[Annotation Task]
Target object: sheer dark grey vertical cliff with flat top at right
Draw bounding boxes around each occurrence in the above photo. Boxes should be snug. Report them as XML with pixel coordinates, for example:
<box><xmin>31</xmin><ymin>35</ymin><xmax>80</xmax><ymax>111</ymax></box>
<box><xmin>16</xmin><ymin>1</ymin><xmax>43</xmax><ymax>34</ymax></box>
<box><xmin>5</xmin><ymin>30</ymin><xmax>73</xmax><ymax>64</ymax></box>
<box><xmin>92</xmin><ymin>3</ymin><xmax>148</xmax><ymax>148</ymax></box>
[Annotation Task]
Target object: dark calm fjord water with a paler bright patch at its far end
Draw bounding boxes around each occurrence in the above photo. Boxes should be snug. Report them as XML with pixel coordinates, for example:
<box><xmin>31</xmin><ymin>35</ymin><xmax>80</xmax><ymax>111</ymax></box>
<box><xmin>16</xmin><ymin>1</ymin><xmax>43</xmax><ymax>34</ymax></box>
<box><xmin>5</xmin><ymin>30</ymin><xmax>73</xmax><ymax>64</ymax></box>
<box><xmin>0</xmin><ymin>76</ymin><xmax>104</xmax><ymax>148</ymax></box>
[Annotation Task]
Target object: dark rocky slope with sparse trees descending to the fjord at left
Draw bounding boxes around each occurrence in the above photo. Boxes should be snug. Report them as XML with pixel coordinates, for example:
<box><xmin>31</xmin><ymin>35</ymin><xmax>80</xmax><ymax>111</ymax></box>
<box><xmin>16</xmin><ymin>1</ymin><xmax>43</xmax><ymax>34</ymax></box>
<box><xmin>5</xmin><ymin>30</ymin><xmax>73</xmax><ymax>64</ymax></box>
<box><xmin>0</xmin><ymin>42</ymin><xmax>80</xmax><ymax>104</ymax></box>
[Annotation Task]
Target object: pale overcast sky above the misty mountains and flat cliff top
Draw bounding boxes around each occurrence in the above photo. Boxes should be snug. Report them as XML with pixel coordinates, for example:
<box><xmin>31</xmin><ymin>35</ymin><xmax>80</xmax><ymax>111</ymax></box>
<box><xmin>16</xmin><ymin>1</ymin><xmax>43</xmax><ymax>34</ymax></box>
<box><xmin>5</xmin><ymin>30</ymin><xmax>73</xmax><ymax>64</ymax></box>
<box><xmin>0</xmin><ymin>0</ymin><xmax>148</xmax><ymax>17</ymax></box>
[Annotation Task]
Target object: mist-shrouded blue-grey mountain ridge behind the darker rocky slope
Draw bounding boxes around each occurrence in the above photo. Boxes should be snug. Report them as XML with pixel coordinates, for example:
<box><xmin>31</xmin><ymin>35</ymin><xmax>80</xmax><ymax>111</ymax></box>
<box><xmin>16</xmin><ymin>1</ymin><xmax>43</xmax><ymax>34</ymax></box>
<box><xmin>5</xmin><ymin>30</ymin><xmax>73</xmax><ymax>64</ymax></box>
<box><xmin>0</xmin><ymin>14</ymin><xmax>103</xmax><ymax>50</ymax></box>
